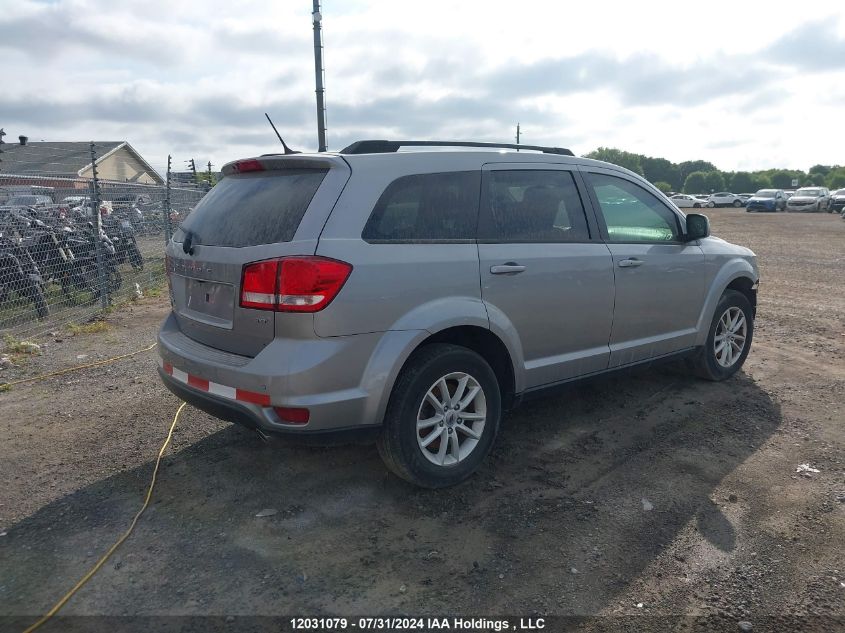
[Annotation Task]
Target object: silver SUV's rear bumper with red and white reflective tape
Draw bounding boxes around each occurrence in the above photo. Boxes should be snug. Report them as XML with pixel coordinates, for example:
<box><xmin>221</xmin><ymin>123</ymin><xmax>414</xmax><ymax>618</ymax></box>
<box><xmin>158</xmin><ymin>314</ymin><xmax>422</xmax><ymax>435</ymax></box>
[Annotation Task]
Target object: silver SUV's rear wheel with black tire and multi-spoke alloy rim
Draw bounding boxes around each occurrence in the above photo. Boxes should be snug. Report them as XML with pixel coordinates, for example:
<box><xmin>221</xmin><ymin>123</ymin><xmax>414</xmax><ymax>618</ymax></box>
<box><xmin>377</xmin><ymin>343</ymin><xmax>502</xmax><ymax>488</ymax></box>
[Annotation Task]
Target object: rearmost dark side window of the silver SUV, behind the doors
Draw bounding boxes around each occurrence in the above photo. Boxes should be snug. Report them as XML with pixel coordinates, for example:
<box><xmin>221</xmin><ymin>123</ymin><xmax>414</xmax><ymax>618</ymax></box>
<box><xmin>361</xmin><ymin>171</ymin><xmax>481</xmax><ymax>243</ymax></box>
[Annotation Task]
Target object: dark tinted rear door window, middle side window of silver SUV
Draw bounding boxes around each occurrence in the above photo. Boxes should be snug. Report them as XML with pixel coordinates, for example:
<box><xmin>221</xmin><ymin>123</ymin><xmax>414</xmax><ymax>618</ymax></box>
<box><xmin>479</xmin><ymin>169</ymin><xmax>590</xmax><ymax>242</ymax></box>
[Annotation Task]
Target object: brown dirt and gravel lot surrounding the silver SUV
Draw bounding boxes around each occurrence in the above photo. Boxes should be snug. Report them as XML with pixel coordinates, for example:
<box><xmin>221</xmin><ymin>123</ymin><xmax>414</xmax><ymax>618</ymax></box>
<box><xmin>0</xmin><ymin>209</ymin><xmax>845</xmax><ymax>631</ymax></box>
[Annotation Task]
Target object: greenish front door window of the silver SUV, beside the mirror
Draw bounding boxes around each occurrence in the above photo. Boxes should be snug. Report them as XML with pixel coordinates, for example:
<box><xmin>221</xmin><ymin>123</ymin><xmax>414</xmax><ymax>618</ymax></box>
<box><xmin>588</xmin><ymin>174</ymin><xmax>678</xmax><ymax>242</ymax></box>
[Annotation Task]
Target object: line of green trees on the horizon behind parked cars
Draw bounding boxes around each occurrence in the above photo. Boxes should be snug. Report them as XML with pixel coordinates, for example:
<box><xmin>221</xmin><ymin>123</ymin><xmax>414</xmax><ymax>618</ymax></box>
<box><xmin>586</xmin><ymin>147</ymin><xmax>845</xmax><ymax>193</ymax></box>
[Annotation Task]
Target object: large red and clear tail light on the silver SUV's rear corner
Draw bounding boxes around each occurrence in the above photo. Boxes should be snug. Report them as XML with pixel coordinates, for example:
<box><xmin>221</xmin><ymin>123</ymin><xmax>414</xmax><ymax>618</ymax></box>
<box><xmin>241</xmin><ymin>256</ymin><xmax>352</xmax><ymax>312</ymax></box>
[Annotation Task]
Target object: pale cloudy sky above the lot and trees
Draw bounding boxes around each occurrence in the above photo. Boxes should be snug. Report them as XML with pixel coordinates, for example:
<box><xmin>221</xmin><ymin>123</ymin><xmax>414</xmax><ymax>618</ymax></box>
<box><xmin>0</xmin><ymin>0</ymin><xmax>845</xmax><ymax>175</ymax></box>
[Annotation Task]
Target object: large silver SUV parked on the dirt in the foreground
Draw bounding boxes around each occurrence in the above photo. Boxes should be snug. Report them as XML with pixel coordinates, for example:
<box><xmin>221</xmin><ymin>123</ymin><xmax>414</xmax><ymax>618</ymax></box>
<box><xmin>159</xmin><ymin>141</ymin><xmax>758</xmax><ymax>487</ymax></box>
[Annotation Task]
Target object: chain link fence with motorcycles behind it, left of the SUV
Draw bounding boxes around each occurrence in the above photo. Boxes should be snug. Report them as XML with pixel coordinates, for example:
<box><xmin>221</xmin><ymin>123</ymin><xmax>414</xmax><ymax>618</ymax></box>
<box><xmin>0</xmin><ymin>144</ymin><xmax>209</xmax><ymax>340</ymax></box>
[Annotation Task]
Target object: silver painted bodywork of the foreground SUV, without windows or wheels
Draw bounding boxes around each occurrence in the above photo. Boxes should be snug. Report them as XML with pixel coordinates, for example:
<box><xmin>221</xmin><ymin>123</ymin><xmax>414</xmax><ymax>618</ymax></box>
<box><xmin>159</xmin><ymin>151</ymin><xmax>757</xmax><ymax>433</ymax></box>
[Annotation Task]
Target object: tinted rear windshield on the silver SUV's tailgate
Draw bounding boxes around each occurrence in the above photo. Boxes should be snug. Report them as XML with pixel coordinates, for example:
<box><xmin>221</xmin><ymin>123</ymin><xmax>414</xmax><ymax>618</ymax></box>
<box><xmin>173</xmin><ymin>169</ymin><xmax>328</xmax><ymax>247</ymax></box>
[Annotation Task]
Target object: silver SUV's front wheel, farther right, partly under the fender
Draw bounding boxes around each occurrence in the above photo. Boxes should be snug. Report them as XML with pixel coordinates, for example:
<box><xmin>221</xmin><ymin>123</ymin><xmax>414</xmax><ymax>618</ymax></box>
<box><xmin>691</xmin><ymin>290</ymin><xmax>754</xmax><ymax>381</ymax></box>
